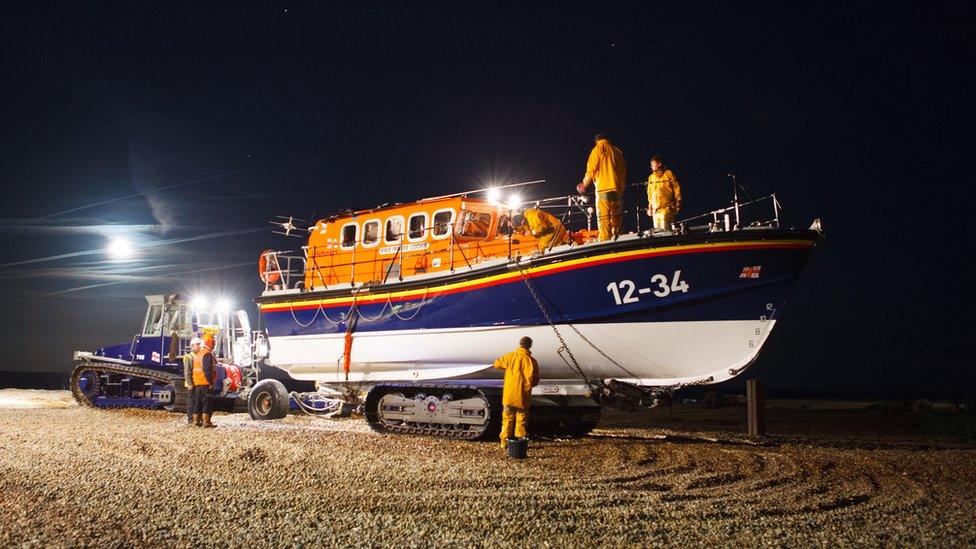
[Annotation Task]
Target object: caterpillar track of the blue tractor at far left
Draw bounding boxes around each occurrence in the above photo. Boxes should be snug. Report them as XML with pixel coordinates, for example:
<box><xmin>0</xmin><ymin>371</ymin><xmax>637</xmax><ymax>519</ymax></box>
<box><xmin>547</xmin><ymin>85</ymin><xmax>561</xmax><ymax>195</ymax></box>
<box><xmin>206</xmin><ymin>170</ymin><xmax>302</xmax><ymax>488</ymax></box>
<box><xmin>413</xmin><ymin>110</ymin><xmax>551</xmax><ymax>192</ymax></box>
<box><xmin>71</xmin><ymin>361</ymin><xmax>187</xmax><ymax>411</ymax></box>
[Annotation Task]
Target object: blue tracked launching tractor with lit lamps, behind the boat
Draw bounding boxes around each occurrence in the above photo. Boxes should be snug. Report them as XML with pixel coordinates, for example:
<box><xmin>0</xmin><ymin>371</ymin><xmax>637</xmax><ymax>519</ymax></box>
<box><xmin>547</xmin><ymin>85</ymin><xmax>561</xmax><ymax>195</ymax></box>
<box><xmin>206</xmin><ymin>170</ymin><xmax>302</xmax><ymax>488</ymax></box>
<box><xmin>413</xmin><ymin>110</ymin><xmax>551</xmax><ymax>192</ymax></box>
<box><xmin>71</xmin><ymin>295</ymin><xmax>263</xmax><ymax>411</ymax></box>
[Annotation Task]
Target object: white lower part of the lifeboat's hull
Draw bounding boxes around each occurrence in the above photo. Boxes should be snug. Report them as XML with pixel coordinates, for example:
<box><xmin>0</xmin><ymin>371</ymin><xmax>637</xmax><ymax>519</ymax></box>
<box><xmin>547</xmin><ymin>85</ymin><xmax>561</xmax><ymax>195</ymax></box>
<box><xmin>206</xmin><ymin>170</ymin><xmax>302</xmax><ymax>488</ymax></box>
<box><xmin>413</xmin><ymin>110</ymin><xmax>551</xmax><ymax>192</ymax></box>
<box><xmin>269</xmin><ymin>319</ymin><xmax>776</xmax><ymax>394</ymax></box>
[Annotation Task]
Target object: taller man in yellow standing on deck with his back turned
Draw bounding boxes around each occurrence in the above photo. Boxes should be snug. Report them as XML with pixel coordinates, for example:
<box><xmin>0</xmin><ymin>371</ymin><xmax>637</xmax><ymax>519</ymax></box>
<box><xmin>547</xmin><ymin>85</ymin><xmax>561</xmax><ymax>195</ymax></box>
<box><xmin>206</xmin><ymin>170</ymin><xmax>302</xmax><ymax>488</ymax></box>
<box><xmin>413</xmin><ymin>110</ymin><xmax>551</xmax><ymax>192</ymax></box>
<box><xmin>576</xmin><ymin>133</ymin><xmax>627</xmax><ymax>241</ymax></box>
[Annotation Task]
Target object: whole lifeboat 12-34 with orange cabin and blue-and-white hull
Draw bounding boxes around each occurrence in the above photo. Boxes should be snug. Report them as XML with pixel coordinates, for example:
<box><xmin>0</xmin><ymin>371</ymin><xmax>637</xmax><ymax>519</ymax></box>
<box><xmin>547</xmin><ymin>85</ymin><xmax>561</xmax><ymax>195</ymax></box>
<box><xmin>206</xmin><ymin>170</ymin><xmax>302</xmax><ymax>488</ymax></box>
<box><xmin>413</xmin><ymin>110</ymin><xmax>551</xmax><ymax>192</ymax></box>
<box><xmin>256</xmin><ymin>182</ymin><xmax>821</xmax><ymax>438</ymax></box>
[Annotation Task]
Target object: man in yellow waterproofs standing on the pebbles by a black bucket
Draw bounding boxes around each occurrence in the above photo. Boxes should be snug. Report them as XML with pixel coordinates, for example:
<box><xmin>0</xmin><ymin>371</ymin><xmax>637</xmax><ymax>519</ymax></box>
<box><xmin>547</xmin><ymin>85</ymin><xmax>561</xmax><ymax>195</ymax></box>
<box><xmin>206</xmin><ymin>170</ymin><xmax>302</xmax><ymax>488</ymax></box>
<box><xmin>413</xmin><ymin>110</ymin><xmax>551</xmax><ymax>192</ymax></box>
<box><xmin>493</xmin><ymin>337</ymin><xmax>539</xmax><ymax>449</ymax></box>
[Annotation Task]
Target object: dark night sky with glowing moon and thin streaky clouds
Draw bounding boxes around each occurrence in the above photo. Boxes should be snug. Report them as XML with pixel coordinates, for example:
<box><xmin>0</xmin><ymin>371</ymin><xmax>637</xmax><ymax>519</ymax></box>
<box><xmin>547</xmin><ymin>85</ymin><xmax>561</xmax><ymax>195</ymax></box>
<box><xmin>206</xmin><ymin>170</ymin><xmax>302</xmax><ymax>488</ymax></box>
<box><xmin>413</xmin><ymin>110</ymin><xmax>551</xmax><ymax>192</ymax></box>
<box><xmin>0</xmin><ymin>2</ymin><xmax>976</xmax><ymax>392</ymax></box>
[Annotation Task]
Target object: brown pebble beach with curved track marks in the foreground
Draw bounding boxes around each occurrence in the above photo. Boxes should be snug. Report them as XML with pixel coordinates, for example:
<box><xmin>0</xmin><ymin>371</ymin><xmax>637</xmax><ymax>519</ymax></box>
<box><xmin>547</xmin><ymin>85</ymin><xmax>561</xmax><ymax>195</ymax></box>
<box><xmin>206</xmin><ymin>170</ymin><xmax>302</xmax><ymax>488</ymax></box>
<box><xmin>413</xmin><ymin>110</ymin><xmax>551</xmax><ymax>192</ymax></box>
<box><xmin>0</xmin><ymin>389</ymin><xmax>976</xmax><ymax>547</ymax></box>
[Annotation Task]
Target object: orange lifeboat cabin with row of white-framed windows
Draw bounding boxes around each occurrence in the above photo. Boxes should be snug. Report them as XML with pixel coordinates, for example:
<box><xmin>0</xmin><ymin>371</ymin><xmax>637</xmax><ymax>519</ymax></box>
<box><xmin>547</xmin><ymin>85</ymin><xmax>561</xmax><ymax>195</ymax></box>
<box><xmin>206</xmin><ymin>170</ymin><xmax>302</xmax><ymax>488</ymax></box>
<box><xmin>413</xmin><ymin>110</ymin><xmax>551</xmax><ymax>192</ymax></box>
<box><xmin>305</xmin><ymin>197</ymin><xmax>556</xmax><ymax>289</ymax></box>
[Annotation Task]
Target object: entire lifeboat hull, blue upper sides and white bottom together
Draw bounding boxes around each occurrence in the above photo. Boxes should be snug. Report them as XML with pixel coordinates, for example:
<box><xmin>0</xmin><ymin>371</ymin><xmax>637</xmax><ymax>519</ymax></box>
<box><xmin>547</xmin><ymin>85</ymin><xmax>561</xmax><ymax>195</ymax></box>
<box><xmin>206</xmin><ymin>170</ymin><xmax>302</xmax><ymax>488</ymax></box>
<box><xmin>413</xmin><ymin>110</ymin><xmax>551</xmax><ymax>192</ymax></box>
<box><xmin>257</xmin><ymin>230</ymin><xmax>819</xmax><ymax>385</ymax></box>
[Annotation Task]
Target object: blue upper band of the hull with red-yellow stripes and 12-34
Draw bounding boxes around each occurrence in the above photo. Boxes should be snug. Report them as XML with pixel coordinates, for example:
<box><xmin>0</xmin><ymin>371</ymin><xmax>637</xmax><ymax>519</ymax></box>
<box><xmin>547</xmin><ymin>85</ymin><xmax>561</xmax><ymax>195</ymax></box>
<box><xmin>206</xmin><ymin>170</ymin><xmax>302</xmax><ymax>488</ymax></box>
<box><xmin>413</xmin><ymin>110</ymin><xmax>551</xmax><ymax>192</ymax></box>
<box><xmin>258</xmin><ymin>231</ymin><xmax>816</xmax><ymax>337</ymax></box>
